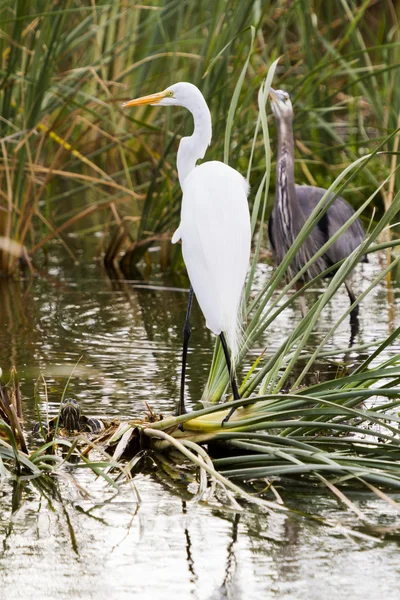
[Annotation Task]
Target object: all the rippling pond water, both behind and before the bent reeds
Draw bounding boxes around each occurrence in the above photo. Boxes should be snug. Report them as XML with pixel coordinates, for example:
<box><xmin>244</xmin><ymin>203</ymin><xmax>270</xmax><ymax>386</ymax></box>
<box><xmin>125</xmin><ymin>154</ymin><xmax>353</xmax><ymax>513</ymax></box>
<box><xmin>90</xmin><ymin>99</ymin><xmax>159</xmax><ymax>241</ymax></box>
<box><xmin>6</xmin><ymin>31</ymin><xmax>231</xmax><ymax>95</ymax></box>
<box><xmin>0</xmin><ymin>241</ymin><xmax>400</xmax><ymax>600</ymax></box>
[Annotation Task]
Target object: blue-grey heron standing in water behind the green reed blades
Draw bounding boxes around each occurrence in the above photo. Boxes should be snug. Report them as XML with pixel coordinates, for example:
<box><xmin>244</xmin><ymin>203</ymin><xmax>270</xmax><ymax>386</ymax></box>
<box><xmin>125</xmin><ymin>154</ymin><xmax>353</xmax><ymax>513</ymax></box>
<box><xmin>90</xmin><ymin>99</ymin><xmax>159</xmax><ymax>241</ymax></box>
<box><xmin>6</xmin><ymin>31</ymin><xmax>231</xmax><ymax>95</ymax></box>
<box><xmin>268</xmin><ymin>88</ymin><xmax>366</xmax><ymax>325</ymax></box>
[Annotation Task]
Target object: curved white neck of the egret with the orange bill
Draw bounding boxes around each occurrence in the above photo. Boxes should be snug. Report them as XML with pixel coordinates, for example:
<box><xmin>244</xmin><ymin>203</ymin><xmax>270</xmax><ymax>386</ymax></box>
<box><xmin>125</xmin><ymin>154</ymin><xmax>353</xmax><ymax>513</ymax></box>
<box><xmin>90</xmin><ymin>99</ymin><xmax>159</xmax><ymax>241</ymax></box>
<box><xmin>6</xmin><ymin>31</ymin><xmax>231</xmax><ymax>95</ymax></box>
<box><xmin>177</xmin><ymin>94</ymin><xmax>212</xmax><ymax>186</ymax></box>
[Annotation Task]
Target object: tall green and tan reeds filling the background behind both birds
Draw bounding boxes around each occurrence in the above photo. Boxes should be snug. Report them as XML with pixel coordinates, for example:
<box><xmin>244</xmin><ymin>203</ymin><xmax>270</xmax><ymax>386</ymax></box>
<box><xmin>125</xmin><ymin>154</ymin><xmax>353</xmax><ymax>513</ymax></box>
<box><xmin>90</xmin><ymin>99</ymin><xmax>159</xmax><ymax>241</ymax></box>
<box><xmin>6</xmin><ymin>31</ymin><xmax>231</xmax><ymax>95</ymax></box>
<box><xmin>0</xmin><ymin>0</ymin><xmax>400</xmax><ymax>274</ymax></box>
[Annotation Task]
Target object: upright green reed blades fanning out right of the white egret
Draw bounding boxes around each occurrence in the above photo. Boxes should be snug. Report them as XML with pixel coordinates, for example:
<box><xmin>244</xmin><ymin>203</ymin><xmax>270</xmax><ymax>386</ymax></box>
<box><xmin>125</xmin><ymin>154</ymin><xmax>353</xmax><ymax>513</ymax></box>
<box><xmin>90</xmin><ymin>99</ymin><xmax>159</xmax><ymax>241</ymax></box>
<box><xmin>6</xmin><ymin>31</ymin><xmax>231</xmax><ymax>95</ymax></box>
<box><xmin>203</xmin><ymin>52</ymin><xmax>400</xmax><ymax>402</ymax></box>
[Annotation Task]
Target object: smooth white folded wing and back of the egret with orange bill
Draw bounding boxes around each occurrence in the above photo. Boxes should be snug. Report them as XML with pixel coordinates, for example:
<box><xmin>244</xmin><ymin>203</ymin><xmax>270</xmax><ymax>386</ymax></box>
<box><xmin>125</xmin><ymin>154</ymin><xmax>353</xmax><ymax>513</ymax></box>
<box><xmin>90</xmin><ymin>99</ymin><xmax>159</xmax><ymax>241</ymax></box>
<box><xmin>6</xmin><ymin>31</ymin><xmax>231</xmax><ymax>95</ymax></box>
<box><xmin>178</xmin><ymin>161</ymin><xmax>251</xmax><ymax>350</ymax></box>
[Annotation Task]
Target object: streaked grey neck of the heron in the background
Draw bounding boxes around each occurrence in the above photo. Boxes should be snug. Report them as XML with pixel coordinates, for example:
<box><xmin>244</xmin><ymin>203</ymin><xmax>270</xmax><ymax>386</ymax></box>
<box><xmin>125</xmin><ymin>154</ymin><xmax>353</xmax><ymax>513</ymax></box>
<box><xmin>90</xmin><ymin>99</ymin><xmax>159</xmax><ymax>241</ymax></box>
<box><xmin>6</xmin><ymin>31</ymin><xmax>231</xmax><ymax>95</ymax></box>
<box><xmin>276</xmin><ymin>118</ymin><xmax>302</xmax><ymax>238</ymax></box>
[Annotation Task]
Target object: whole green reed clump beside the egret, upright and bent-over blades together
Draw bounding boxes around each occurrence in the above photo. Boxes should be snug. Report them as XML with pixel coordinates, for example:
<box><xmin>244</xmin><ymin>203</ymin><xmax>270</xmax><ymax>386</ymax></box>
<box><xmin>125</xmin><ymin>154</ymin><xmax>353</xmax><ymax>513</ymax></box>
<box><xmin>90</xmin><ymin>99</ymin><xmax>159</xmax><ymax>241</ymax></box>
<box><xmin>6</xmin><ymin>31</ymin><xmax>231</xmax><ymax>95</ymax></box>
<box><xmin>101</xmin><ymin>61</ymin><xmax>400</xmax><ymax>518</ymax></box>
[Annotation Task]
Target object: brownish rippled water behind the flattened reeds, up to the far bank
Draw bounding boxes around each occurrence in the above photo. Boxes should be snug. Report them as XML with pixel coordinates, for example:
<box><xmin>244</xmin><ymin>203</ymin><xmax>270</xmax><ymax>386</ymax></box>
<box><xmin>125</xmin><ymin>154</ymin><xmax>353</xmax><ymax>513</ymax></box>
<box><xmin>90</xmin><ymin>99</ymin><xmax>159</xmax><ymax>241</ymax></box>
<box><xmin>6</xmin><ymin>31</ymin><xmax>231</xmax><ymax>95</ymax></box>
<box><xmin>0</xmin><ymin>254</ymin><xmax>399</xmax><ymax>416</ymax></box>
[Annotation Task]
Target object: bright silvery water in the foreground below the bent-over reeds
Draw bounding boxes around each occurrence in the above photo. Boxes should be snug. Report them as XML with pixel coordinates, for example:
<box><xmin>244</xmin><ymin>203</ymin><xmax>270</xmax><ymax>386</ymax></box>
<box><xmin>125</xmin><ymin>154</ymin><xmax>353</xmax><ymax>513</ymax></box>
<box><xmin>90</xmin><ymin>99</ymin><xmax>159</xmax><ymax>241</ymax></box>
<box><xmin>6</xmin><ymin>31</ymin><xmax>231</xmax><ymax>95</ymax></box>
<box><xmin>0</xmin><ymin>462</ymin><xmax>400</xmax><ymax>600</ymax></box>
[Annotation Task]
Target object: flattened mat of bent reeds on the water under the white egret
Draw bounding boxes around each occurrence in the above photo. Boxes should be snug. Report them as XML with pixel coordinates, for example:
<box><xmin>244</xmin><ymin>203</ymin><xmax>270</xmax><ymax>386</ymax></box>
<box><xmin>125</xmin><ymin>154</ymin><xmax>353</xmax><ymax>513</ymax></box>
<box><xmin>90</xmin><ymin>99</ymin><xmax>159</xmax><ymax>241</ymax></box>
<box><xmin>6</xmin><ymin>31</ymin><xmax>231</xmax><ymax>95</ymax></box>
<box><xmin>0</xmin><ymin>344</ymin><xmax>400</xmax><ymax>540</ymax></box>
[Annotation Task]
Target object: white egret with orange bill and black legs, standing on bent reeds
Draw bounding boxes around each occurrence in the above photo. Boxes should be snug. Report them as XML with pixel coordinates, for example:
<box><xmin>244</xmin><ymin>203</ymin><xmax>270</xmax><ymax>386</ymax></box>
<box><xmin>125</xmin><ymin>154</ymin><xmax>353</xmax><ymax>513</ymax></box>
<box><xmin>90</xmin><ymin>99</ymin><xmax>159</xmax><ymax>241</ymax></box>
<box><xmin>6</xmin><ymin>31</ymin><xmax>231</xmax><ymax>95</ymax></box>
<box><xmin>124</xmin><ymin>82</ymin><xmax>251</xmax><ymax>420</ymax></box>
